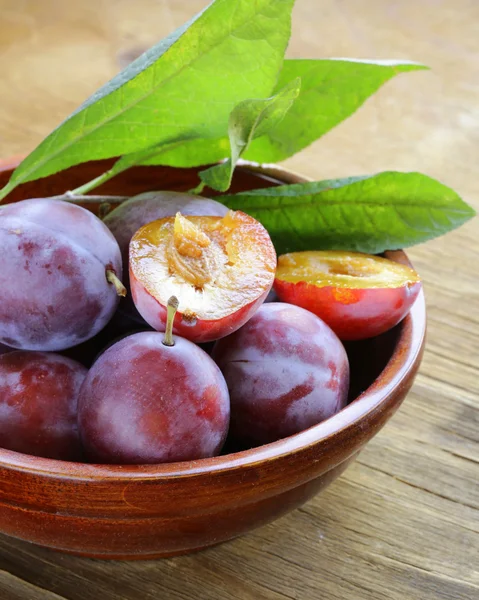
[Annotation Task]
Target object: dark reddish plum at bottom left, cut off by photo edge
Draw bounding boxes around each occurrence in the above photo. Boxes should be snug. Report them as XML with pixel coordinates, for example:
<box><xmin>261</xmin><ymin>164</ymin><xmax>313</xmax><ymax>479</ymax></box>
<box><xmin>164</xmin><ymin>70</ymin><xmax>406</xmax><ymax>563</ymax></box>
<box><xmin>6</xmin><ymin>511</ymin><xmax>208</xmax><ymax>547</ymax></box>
<box><xmin>0</xmin><ymin>350</ymin><xmax>87</xmax><ymax>461</ymax></box>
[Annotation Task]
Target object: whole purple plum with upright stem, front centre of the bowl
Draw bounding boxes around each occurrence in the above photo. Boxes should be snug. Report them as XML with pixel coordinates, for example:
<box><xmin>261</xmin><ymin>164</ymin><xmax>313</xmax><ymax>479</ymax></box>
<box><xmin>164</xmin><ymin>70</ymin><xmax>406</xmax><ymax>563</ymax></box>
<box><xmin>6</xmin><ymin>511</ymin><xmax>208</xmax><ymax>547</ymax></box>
<box><xmin>78</xmin><ymin>332</ymin><xmax>230</xmax><ymax>464</ymax></box>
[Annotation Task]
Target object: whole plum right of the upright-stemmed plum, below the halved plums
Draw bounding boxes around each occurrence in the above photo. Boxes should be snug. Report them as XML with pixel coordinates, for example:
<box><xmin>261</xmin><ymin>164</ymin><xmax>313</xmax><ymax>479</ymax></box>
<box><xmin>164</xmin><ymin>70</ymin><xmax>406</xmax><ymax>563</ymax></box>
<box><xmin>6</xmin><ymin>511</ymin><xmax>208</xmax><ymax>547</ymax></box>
<box><xmin>212</xmin><ymin>302</ymin><xmax>349</xmax><ymax>447</ymax></box>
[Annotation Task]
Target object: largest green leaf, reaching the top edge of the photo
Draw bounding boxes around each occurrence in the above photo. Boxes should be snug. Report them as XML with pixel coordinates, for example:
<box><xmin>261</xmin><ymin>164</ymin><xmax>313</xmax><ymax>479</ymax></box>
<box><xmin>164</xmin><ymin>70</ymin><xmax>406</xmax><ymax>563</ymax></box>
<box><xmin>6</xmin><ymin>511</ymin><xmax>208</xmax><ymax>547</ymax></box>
<box><xmin>0</xmin><ymin>0</ymin><xmax>294</xmax><ymax>199</ymax></box>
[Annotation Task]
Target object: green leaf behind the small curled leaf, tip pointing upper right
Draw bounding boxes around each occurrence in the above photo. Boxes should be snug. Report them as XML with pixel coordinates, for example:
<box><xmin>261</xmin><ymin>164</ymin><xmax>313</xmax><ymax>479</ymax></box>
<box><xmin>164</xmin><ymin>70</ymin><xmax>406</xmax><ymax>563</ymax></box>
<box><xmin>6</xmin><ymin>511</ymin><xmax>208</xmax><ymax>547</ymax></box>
<box><xmin>245</xmin><ymin>59</ymin><xmax>427</xmax><ymax>162</ymax></box>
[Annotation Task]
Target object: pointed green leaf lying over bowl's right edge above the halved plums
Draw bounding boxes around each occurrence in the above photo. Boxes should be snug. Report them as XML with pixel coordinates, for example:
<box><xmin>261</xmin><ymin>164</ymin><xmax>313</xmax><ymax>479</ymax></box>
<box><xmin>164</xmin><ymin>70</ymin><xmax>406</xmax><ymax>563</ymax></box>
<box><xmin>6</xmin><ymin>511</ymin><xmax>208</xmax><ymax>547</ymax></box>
<box><xmin>217</xmin><ymin>171</ymin><xmax>475</xmax><ymax>254</ymax></box>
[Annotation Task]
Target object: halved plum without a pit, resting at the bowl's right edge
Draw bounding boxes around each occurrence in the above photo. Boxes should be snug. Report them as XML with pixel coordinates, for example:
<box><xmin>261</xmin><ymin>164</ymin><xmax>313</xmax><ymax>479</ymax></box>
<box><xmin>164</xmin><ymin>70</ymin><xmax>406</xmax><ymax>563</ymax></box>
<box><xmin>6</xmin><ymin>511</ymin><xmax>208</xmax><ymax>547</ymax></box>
<box><xmin>274</xmin><ymin>251</ymin><xmax>421</xmax><ymax>340</ymax></box>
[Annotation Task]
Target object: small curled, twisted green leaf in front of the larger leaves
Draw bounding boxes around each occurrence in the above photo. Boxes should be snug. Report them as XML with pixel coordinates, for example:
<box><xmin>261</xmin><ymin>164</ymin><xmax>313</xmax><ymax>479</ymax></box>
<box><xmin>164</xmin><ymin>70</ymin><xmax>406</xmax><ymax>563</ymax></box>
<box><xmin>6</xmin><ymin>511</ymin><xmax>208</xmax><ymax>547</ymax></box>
<box><xmin>199</xmin><ymin>78</ymin><xmax>301</xmax><ymax>192</ymax></box>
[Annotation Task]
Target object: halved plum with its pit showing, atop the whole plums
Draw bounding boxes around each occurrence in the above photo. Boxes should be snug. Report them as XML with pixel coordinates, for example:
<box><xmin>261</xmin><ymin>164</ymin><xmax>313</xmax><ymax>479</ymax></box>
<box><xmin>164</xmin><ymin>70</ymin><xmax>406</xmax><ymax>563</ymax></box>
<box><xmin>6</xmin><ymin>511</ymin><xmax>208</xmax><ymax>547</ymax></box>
<box><xmin>130</xmin><ymin>211</ymin><xmax>276</xmax><ymax>342</ymax></box>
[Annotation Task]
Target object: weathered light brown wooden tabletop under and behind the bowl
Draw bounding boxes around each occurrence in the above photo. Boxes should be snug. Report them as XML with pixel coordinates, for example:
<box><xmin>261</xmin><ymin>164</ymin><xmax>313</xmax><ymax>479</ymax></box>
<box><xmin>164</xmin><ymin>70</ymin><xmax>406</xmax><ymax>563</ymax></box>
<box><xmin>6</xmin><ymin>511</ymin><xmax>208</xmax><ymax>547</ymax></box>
<box><xmin>0</xmin><ymin>0</ymin><xmax>479</xmax><ymax>600</ymax></box>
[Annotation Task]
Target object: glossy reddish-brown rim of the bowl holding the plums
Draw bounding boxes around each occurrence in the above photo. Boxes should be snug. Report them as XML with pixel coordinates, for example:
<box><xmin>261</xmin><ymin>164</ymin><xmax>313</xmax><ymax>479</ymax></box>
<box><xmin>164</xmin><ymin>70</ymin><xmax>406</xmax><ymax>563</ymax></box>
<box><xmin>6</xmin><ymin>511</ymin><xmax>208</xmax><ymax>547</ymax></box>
<box><xmin>0</xmin><ymin>157</ymin><xmax>426</xmax><ymax>481</ymax></box>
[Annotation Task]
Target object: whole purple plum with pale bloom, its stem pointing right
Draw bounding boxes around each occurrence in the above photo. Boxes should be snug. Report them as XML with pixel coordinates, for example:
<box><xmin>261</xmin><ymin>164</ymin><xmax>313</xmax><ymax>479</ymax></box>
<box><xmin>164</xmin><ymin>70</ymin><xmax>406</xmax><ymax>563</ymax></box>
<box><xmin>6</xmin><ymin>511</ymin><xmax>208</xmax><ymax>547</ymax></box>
<box><xmin>0</xmin><ymin>198</ymin><xmax>122</xmax><ymax>351</ymax></box>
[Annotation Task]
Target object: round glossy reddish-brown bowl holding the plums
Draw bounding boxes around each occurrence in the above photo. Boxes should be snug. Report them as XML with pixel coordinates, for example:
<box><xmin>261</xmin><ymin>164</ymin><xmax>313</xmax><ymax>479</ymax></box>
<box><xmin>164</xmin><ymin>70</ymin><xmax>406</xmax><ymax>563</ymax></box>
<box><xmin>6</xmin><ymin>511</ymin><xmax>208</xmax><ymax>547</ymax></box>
<box><xmin>0</xmin><ymin>161</ymin><xmax>426</xmax><ymax>559</ymax></box>
